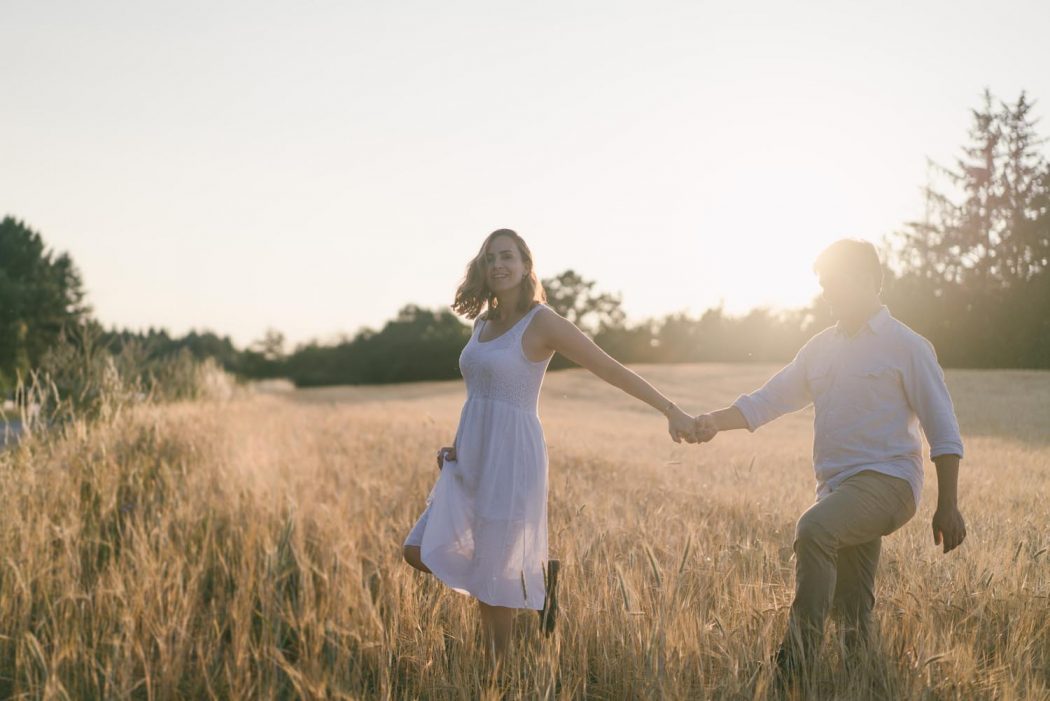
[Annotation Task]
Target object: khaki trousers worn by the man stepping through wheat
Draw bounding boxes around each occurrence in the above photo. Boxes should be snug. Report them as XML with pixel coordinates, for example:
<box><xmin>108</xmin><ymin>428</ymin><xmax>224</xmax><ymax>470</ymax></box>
<box><xmin>783</xmin><ymin>471</ymin><xmax>916</xmax><ymax>664</ymax></box>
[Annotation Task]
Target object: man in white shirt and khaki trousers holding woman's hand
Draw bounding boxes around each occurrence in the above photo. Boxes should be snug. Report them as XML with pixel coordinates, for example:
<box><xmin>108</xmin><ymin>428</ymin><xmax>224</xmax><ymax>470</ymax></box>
<box><xmin>696</xmin><ymin>240</ymin><xmax>966</xmax><ymax>679</ymax></box>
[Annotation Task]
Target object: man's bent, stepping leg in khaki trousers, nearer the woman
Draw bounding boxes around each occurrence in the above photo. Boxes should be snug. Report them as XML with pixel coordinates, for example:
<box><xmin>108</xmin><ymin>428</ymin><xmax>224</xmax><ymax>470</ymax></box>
<box><xmin>778</xmin><ymin>472</ymin><xmax>915</xmax><ymax>672</ymax></box>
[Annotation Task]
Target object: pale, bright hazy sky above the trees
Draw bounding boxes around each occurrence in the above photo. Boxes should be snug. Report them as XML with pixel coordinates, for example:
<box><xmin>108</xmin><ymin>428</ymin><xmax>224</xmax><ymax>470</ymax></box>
<box><xmin>0</xmin><ymin>0</ymin><xmax>1050</xmax><ymax>345</ymax></box>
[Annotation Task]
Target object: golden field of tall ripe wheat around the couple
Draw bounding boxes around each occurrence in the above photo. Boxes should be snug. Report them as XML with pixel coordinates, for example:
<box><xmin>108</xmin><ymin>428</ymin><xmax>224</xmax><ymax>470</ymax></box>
<box><xmin>0</xmin><ymin>365</ymin><xmax>1050</xmax><ymax>699</ymax></box>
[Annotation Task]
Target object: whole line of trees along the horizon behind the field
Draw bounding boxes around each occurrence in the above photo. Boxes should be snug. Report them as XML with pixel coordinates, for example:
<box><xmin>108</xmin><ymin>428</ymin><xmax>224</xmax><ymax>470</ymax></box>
<box><xmin>0</xmin><ymin>90</ymin><xmax>1050</xmax><ymax>395</ymax></box>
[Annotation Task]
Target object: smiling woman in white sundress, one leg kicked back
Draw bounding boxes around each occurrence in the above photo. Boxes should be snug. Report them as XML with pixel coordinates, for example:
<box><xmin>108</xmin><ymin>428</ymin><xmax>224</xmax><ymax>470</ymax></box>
<box><xmin>404</xmin><ymin>229</ymin><xmax>695</xmax><ymax>659</ymax></box>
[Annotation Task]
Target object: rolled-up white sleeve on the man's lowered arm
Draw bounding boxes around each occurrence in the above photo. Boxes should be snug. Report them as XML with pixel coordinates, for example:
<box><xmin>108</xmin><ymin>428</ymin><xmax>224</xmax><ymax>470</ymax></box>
<box><xmin>904</xmin><ymin>339</ymin><xmax>963</xmax><ymax>459</ymax></box>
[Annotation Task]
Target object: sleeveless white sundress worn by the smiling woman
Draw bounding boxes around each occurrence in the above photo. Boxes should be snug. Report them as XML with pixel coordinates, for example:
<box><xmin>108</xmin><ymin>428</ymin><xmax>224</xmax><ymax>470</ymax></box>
<box><xmin>405</xmin><ymin>304</ymin><xmax>550</xmax><ymax>610</ymax></box>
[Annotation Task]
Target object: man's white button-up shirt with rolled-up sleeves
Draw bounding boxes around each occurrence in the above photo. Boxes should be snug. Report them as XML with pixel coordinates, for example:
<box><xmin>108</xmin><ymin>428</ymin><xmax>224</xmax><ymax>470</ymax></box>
<box><xmin>734</xmin><ymin>306</ymin><xmax>963</xmax><ymax>506</ymax></box>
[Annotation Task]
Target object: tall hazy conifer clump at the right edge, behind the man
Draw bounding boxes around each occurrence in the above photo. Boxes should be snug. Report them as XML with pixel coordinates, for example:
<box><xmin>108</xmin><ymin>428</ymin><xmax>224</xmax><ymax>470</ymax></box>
<box><xmin>884</xmin><ymin>90</ymin><xmax>1050</xmax><ymax>367</ymax></box>
